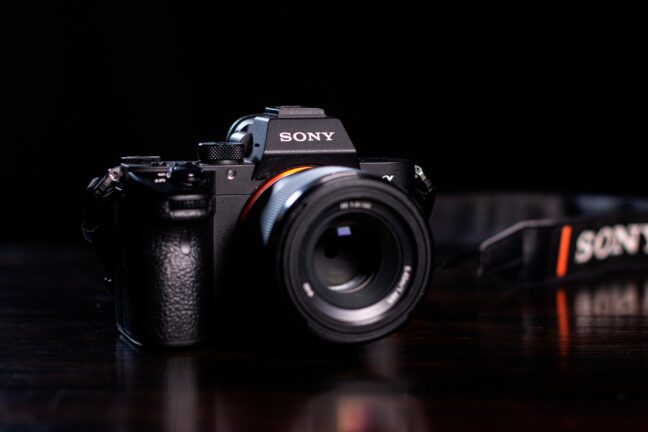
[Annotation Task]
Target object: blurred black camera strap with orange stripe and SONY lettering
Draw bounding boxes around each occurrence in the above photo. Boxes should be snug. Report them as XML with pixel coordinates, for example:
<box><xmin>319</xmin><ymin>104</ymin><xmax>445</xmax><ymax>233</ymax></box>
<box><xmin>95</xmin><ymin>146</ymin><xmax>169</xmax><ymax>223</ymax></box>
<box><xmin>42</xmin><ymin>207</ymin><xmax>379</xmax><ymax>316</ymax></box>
<box><xmin>432</xmin><ymin>194</ymin><xmax>648</xmax><ymax>283</ymax></box>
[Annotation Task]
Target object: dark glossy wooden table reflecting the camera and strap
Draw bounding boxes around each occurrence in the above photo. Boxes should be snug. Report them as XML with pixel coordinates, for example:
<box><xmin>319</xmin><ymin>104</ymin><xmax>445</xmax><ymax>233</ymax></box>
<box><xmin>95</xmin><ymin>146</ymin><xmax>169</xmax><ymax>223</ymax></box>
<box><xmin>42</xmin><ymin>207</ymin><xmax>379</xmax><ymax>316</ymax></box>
<box><xmin>0</xmin><ymin>246</ymin><xmax>648</xmax><ymax>432</ymax></box>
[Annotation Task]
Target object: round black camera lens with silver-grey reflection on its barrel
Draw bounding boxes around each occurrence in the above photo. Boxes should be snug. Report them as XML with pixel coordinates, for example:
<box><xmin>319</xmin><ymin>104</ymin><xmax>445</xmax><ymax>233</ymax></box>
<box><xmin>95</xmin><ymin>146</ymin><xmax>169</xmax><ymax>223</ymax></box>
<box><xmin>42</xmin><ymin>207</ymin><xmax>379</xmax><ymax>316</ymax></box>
<box><xmin>240</xmin><ymin>166</ymin><xmax>432</xmax><ymax>342</ymax></box>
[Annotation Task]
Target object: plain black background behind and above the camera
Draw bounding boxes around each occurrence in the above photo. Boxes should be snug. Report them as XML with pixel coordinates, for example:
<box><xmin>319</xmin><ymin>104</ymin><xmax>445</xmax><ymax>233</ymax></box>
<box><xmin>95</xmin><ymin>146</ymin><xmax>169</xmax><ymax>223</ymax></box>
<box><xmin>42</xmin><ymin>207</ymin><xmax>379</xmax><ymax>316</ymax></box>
<box><xmin>0</xmin><ymin>5</ymin><xmax>648</xmax><ymax>241</ymax></box>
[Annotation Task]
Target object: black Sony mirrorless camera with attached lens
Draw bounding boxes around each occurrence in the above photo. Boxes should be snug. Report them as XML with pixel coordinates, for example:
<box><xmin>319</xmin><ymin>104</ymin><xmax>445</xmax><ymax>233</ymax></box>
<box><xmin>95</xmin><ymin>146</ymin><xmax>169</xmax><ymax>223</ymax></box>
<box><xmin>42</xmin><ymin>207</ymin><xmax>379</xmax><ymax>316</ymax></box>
<box><xmin>83</xmin><ymin>106</ymin><xmax>434</xmax><ymax>346</ymax></box>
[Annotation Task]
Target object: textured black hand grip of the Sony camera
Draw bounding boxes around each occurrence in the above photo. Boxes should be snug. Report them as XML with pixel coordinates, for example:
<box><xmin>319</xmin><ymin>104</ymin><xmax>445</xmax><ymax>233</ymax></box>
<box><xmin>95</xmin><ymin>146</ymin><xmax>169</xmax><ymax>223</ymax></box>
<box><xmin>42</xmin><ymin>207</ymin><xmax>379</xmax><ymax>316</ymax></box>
<box><xmin>116</xmin><ymin>205</ymin><xmax>213</xmax><ymax>346</ymax></box>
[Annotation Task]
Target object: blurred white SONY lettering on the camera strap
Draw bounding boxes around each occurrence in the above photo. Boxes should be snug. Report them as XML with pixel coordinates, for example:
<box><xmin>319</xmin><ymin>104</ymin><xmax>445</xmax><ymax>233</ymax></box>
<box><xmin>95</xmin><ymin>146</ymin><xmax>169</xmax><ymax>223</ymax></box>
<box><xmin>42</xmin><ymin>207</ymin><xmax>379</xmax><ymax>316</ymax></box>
<box><xmin>574</xmin><ymin>223</ymin><xmax>648</xmax><ymax>264</ymax></box>
